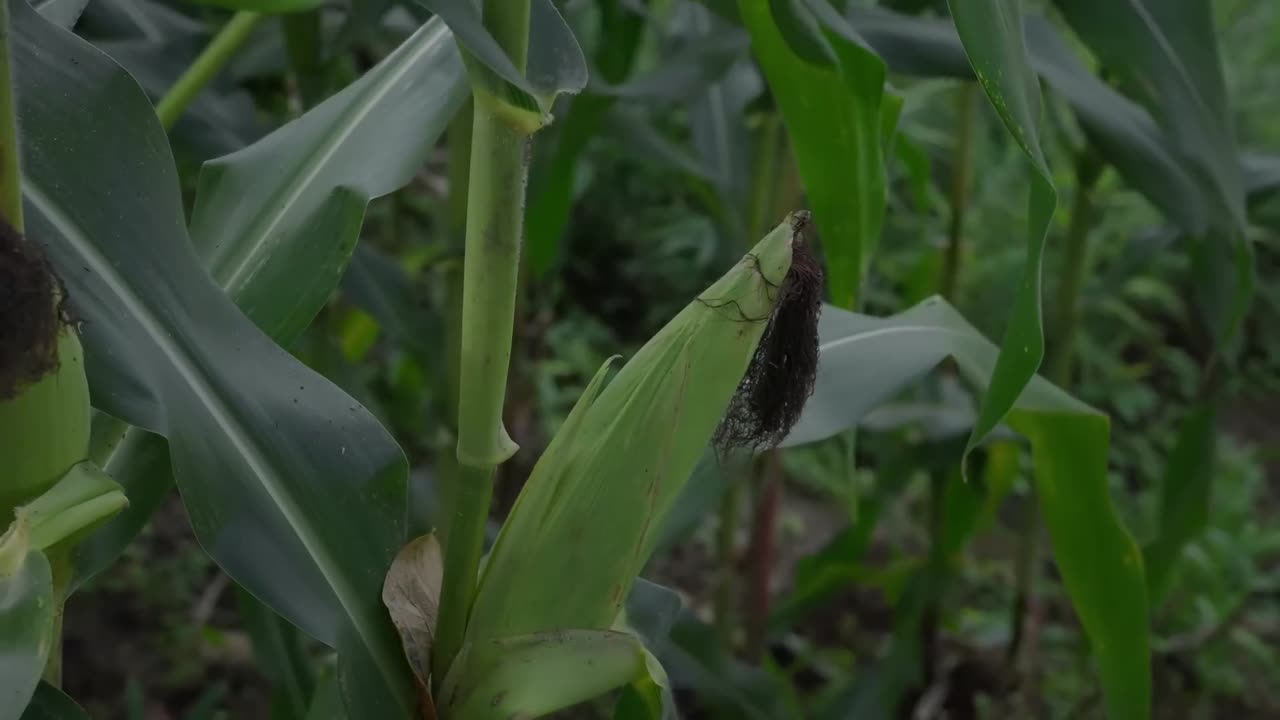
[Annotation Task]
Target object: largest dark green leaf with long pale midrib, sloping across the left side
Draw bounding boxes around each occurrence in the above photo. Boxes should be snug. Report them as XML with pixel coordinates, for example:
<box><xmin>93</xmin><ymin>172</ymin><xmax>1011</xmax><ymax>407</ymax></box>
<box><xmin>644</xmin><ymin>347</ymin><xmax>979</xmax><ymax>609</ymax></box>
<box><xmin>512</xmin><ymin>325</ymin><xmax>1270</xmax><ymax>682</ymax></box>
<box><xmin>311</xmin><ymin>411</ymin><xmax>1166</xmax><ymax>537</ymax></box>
<box><xmin>12</xmin><ymin>0</ymin><xmax>413</xmax><ymax>717</ymax></box>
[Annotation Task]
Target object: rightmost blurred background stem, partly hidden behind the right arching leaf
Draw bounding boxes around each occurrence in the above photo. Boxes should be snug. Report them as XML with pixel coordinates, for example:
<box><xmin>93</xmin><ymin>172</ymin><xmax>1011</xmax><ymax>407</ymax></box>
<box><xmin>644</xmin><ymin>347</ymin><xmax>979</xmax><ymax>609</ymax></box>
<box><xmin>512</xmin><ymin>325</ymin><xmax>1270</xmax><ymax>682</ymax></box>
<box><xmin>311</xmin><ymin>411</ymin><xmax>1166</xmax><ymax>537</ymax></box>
<box><xmin>1005</xmin><ymin>150</ymin><xmax>1103</xmax><ymax>665</ymax></box>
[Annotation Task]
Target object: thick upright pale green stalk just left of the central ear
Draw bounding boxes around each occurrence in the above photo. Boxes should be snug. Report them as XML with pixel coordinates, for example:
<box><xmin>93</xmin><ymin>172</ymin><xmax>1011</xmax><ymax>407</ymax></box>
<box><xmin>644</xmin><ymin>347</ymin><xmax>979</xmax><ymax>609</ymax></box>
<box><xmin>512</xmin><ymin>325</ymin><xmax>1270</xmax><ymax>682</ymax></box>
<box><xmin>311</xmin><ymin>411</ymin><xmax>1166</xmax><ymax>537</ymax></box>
<box><xmin>431</xmin><ymin>0</ymin><xmax>530</xmax><ymax>682</ymax></box>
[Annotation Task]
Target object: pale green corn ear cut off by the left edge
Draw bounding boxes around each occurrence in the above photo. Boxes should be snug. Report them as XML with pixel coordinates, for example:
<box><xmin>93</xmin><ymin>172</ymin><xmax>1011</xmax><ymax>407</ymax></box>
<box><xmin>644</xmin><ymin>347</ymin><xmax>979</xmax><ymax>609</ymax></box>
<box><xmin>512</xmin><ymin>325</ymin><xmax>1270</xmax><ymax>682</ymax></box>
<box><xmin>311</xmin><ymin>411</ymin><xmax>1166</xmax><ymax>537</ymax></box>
<box><xmin>0</xmin><ymin>327</ymin><xmax>90</xmax><ymax>515</ymax></box>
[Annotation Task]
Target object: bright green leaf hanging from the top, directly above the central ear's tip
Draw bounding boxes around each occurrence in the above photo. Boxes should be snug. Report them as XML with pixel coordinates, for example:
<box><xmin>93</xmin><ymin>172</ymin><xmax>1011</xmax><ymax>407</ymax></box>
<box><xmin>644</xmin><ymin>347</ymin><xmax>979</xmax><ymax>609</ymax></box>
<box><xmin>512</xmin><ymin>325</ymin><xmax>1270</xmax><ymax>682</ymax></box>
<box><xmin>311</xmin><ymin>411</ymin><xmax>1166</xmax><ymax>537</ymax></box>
<box><xmin>739</xmin><ymin>0</ymin><xmax>887</xmax><ymax>307</ymax></box>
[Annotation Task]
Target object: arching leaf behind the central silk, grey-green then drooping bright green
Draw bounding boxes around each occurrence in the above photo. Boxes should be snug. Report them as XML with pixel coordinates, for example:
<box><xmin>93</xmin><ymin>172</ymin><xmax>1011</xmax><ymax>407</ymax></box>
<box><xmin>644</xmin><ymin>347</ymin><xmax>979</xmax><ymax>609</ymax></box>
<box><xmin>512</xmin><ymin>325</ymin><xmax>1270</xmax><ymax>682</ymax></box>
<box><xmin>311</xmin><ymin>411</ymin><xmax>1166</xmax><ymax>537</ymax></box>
<box><xmin>783</xmin><ymin>299</ymin><xmax>1151</xmax><ymax>717</ymax></box>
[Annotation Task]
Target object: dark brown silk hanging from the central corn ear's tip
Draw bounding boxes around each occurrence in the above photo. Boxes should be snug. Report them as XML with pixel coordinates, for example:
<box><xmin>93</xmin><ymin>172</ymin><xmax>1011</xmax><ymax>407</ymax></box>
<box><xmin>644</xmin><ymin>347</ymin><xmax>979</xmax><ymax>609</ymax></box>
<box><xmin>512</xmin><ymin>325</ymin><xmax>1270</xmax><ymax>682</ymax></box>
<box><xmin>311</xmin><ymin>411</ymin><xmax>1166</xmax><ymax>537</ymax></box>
<box><xmin>714</xmin><ymin>211</ymin><xmax>822</xmax><ymax>452</ymax></box>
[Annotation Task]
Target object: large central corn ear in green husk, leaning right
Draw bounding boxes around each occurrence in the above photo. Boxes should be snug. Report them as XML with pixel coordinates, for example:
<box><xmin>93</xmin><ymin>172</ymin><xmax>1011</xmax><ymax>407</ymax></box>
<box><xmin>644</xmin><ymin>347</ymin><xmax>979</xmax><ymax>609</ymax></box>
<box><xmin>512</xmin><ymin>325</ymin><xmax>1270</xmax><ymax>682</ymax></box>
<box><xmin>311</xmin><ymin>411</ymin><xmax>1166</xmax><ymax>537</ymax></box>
<box><xmin>466</xmin><ymin>218</ymin><xmax>795</xmax><ymax>638</ymax></box>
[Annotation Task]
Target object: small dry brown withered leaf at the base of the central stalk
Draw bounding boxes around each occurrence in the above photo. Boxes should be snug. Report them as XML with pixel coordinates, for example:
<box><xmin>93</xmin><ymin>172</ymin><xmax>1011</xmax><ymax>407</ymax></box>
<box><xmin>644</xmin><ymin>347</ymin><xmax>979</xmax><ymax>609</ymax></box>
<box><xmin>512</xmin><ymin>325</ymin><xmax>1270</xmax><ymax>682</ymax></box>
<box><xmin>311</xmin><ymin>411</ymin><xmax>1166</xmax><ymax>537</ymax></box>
<box><xmin>383</xmin><ymin>534</ymin><xmax>444</xmax><ymax>688</ymax></box>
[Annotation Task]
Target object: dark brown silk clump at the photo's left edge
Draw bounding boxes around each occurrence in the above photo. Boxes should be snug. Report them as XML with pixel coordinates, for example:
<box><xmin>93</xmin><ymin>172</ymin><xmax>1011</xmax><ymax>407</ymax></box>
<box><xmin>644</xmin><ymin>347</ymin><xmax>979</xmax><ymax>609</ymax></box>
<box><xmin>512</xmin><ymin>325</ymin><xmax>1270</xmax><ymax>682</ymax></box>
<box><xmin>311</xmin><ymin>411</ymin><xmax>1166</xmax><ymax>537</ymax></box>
<box><xmin>0</xmin><ymin>219</ymin><xmax>65</xmax><ymax>401</ymax></box>
